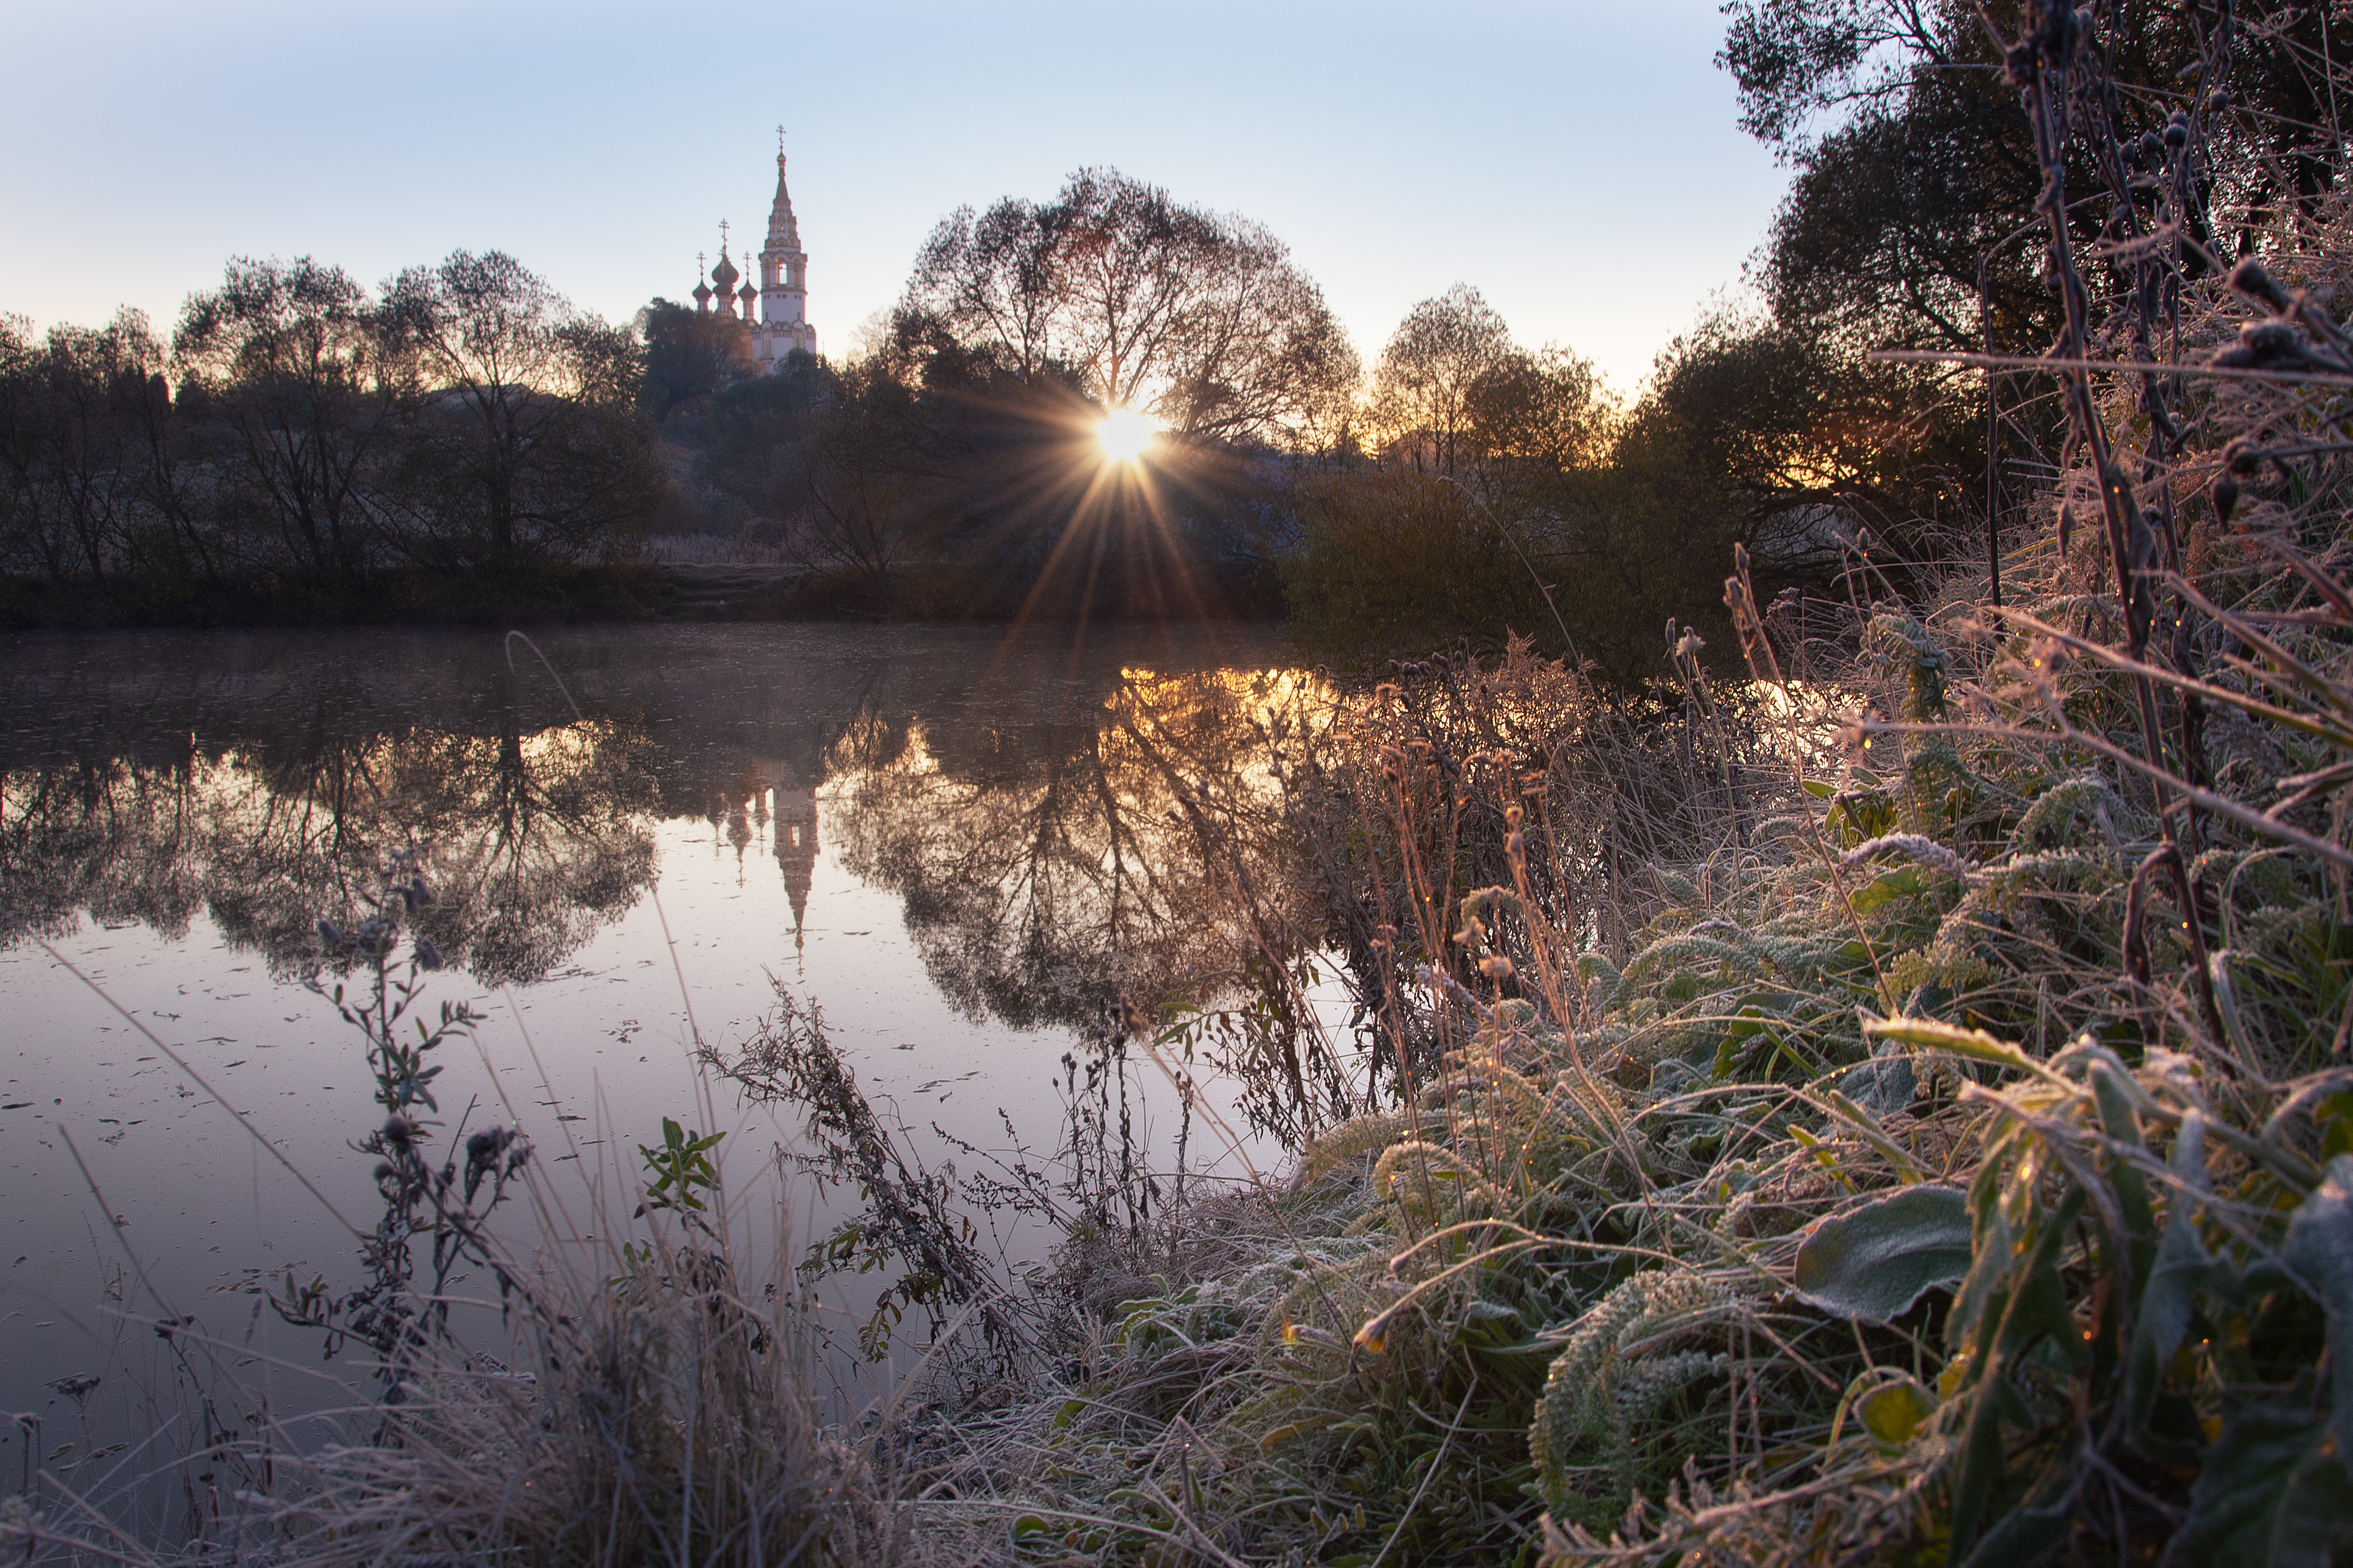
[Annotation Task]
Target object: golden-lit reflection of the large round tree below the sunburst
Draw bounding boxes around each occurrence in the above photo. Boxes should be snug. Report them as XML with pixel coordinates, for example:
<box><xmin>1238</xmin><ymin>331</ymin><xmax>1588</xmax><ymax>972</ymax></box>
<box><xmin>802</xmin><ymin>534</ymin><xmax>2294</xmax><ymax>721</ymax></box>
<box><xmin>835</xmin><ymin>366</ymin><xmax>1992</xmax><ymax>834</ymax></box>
<box><xmin>828</xmin><ymin>672</ymin><xmax>1313</xmax><ymax>1027</ymax></box>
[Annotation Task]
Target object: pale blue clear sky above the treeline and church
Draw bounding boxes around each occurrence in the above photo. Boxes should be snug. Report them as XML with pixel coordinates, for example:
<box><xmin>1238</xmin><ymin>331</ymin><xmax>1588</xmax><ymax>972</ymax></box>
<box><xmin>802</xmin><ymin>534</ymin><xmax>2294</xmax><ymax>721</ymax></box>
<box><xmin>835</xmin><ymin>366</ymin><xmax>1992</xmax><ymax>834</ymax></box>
<box><xmin>0</xmin><ymin>0</ymin><xmax>1786</xmax><ymax>393</ymax></box>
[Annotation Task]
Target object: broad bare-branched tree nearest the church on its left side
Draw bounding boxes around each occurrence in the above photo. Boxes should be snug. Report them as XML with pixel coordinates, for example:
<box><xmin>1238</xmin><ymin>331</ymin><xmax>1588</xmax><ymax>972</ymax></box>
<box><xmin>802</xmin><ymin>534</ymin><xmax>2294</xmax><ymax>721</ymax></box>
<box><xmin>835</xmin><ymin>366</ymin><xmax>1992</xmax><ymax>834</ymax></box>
<box><xmin>384</xmin><ymin>252</ymin><xmax>664</xmax><ymax>572</ymax></box>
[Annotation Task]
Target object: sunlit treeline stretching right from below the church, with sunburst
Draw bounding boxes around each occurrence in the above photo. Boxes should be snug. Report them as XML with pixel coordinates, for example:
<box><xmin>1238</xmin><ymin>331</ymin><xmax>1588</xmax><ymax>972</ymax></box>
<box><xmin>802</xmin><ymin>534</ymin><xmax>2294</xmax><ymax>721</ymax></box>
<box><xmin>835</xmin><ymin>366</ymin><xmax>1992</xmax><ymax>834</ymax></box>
<box><xmin>637</xmin><ymin>169</ymin><xmax>1969</xmax><ymax>679</ymax></box>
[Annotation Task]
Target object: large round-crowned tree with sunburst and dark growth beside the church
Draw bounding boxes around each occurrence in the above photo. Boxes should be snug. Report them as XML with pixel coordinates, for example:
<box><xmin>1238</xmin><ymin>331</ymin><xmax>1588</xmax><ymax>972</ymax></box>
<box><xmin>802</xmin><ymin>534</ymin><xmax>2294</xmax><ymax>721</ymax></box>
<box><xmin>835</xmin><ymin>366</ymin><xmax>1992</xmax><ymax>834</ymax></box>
<box><xmin>640</xmin><ymin>169</ymin><xmax>1360</xmax><ymax>616</ymax></box>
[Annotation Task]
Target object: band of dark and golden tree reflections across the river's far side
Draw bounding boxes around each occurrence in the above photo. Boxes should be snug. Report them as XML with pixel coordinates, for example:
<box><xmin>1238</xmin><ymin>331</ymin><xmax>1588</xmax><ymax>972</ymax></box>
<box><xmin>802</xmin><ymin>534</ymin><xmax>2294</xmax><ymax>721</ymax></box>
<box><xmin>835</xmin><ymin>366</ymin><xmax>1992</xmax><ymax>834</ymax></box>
<box><xmin>0</xmin><ymin>627</ymin><xmax>1311</xmax><ymax>1030</ymax></box>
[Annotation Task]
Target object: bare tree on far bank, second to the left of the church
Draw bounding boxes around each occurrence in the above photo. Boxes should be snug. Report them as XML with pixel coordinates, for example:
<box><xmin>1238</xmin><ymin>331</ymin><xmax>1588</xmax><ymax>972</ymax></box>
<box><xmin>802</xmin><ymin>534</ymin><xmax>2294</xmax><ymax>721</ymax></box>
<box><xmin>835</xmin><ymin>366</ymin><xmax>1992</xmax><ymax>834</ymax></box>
<box><xmin>172</xmin><ymin>256</ymin><xmax>412</xmax><ymax>576</ymax></box>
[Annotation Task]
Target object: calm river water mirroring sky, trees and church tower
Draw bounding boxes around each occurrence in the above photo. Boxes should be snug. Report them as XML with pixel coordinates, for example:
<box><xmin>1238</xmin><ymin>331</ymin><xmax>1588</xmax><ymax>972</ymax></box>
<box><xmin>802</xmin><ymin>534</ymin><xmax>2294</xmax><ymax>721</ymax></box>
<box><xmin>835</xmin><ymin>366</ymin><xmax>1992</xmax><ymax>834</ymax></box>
<box><xmin>0</xmin><ymin>626</ymin><xmax>1301</xmax><ymax>1429</ymax></box>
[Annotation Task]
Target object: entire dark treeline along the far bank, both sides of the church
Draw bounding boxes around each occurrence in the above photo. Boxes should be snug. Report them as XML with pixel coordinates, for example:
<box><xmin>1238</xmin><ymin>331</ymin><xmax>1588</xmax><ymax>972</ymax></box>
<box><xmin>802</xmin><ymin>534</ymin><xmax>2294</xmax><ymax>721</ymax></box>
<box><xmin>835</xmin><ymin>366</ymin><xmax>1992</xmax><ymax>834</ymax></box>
<box><xmin>0</xmin><ymin>159</ymin><xmax>1984</xmax><ymax>649</ymax></box>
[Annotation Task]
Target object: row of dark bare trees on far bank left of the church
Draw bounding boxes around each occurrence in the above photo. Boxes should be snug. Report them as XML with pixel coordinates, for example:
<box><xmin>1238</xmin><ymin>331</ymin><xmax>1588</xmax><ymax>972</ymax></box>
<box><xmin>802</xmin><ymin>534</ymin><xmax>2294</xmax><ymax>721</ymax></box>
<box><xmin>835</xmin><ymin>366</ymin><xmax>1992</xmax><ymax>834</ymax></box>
<box><xmin>0</xmin><ymin>252</ymin><xmax>661</xmax><ymax>616</ymax></box>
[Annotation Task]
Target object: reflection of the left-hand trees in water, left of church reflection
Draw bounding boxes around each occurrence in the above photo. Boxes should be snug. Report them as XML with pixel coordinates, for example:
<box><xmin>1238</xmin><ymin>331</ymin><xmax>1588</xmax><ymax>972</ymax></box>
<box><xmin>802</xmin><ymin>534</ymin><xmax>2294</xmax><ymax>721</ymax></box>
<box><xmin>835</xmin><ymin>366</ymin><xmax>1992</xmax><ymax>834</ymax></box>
<box><xmin>0</xmin><ymin>710</ymin><xmax>654</xmax><ymax>985</ymax></box>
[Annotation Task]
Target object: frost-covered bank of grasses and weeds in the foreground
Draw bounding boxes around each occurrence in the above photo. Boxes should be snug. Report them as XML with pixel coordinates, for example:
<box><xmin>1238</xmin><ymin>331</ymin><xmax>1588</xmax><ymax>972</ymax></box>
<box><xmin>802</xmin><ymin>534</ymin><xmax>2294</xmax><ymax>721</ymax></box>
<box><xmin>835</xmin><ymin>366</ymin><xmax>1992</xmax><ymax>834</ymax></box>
<box><xmin>0</xmin><ymin>522</ymin><xmax>2353</xmax><ymax>1568</ymax></box>
